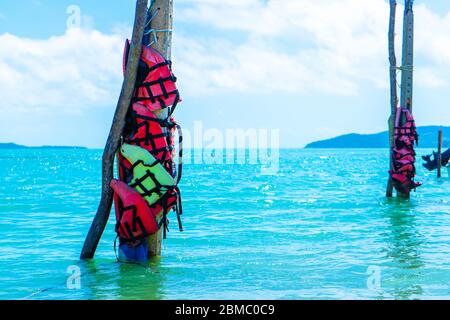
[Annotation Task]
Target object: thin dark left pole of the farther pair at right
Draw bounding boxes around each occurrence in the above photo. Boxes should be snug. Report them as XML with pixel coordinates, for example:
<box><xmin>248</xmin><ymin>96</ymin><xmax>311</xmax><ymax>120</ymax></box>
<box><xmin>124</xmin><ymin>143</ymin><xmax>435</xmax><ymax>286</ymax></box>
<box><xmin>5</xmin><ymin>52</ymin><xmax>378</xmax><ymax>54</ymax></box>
<box><xmin>386</xmin><ymin>0</ymin><xmax>398</xmax><ymax>198</ymax></box>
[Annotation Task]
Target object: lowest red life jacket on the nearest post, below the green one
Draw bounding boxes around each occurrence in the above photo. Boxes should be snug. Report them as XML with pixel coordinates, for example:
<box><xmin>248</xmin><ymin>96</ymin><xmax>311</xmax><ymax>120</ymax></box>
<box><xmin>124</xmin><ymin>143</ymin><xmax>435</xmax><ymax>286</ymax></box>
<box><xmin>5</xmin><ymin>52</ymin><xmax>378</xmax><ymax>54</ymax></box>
<box><xmin>110</xmin><ymin>179</ymin><xmax>159</xmax><ymax>241</ymax></box>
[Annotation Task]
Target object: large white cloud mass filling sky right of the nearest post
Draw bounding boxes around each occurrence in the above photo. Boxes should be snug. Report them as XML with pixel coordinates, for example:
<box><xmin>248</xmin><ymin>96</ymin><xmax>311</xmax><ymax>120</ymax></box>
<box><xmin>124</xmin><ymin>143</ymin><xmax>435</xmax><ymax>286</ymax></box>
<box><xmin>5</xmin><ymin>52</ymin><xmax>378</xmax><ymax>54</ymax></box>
<box><xmin>174</xmin><ymin>0</ymin><xmax>450</xmax><ymax>95</ymax></box>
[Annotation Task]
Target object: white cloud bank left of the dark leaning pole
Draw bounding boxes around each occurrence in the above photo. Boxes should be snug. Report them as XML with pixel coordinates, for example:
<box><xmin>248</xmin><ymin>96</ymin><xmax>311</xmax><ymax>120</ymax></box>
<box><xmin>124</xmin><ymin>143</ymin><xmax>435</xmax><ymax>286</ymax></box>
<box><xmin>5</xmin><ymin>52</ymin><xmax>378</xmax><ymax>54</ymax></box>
<box><xmin>0</xmin><ymin>29</ymin><xmax>124</xmax><ymax>113</ymax></box>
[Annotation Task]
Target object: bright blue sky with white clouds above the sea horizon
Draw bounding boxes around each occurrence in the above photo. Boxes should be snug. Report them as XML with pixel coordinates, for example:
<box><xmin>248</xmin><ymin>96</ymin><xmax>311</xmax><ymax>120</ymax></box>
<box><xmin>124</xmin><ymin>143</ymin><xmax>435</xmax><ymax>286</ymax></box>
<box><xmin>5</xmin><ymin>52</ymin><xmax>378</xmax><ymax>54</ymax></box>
<box><xmin>0</xmin><ymin>0</ymin><xmax>450</xmax><ymax>147</ymax></box>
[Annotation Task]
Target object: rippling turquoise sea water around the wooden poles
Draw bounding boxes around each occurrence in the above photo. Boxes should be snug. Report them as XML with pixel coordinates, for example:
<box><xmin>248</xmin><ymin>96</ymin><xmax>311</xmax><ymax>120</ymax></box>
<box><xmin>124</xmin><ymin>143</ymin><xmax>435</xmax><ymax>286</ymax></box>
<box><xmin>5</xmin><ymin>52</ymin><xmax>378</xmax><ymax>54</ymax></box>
<box><xmin>0</xmin><ymin>150</ymin><xmax>450</xmax><ymax>299</ymax></box>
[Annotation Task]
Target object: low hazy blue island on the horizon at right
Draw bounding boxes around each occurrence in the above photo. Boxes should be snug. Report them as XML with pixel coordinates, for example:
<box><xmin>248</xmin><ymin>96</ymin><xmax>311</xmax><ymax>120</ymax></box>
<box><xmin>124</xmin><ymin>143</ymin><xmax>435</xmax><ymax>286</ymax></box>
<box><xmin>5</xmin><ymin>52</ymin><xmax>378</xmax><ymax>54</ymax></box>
<box><xmin>305</xmin><ymin>126</ymin><xmax>450</xmax><ymax>149</ymax></box>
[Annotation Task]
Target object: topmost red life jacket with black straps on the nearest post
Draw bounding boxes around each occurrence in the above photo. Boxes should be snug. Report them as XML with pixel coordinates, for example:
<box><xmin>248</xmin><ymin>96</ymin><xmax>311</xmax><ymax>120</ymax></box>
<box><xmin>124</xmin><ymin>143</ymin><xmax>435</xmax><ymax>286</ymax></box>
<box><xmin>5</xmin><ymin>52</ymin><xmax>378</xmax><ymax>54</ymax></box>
<box><xmin>123</xmin><ymin>40</ymin><xmax>181</xmax><ymax>115</ymax></box>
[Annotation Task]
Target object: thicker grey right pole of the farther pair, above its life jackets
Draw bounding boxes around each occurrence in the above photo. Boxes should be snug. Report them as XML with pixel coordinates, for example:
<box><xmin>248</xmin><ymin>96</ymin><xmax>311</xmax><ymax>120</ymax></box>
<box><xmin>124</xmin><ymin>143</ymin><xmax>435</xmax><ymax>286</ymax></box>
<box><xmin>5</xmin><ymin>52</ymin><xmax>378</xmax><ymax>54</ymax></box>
<box><xmin>397</xmin><ymin>0</ymin><xmax>414</xmax><ymax>198</ymax></box>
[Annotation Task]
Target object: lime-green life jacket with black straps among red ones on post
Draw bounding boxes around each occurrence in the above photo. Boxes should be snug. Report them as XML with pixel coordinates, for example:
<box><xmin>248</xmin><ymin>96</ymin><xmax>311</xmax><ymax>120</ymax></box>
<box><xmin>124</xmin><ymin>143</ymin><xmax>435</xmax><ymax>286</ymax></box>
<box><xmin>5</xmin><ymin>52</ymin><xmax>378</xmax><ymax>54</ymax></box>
<box><xmin>120</xmin><ymin>143</ymin><xmax>177</xmax><ymax>206</ymax></box>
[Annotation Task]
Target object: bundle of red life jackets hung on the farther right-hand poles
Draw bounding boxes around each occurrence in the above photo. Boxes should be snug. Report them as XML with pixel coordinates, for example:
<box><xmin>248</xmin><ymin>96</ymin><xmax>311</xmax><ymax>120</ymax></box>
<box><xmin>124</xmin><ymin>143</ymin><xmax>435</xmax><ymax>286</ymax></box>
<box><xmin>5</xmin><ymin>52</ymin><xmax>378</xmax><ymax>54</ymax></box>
<box><xmin>389</xmin><ymin>108</ymin><xmax>421</xmax><ymax>193</ymax></box>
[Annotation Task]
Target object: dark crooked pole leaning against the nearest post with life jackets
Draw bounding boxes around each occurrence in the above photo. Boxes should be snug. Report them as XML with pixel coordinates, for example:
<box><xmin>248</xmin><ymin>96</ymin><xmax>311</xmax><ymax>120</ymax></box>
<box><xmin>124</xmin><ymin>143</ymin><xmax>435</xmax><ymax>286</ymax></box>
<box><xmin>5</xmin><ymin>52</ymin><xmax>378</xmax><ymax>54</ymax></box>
<box><xmin>80</xmin><ymin>0</ymin><xmax>148</xmax><ymax>259</ymax></box>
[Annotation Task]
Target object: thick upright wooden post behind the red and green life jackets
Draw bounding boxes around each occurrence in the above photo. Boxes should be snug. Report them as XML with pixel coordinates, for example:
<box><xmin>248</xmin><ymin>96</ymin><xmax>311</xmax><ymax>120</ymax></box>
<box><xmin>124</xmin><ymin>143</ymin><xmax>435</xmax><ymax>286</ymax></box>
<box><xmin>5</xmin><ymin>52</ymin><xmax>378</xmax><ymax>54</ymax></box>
<box><xmin>146</xmin><ymin>0</ymin><xmax>173</xmax><ymax>257</ymax></box>
